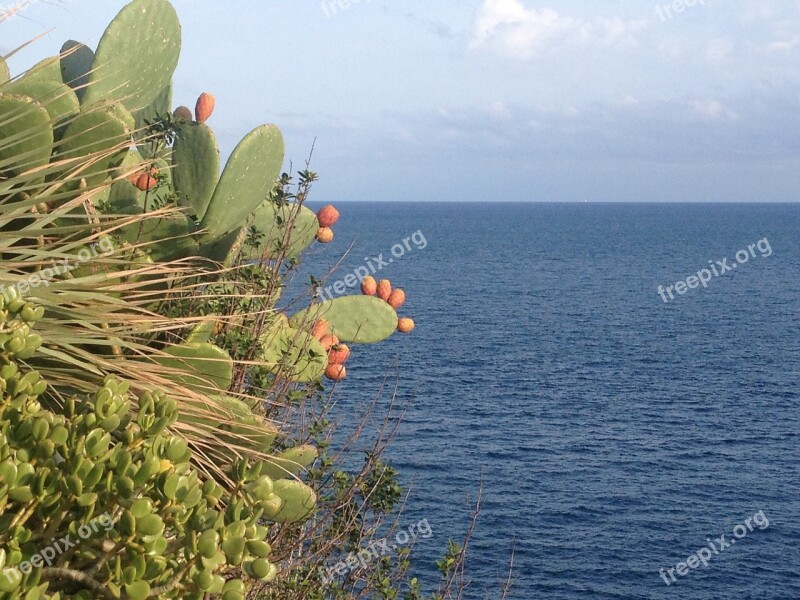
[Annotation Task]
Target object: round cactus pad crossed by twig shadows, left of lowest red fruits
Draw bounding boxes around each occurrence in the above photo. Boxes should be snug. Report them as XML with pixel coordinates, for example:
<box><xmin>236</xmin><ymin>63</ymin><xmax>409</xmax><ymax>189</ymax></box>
<box><xmin>261</xmin><ymin>326</ymin><xmax>328</xmax><ymax>383</ymax></box>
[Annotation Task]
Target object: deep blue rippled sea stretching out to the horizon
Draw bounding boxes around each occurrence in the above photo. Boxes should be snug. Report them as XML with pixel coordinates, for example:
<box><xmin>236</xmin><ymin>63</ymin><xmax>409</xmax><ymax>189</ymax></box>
<box><xmin>296</xmin><ymin>203</ymin><xmax>800</xmax><ymax>600</ymax></box>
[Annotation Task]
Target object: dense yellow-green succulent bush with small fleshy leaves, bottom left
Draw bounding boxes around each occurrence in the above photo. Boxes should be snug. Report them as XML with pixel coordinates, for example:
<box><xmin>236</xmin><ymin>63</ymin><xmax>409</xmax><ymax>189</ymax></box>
<box><xmin>0</xmin><ymin>294</ymin><xmax>316</xmax><ymax>600</ymax></box>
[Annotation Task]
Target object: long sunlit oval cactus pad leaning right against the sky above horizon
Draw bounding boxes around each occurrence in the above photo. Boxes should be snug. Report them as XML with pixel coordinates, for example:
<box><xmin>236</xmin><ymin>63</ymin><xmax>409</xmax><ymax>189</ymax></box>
<box><xmin>200</xmin><ymin>125</ymin><xmax>283</xmax><ymax>240</ymax></box>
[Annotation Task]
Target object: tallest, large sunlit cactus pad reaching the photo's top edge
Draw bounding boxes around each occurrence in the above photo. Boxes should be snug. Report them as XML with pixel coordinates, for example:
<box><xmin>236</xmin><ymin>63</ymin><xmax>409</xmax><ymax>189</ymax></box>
<box><xmin>83</xmin><ymin>0</ymin><xmax>181</xmax><ymax>112</ymax></box>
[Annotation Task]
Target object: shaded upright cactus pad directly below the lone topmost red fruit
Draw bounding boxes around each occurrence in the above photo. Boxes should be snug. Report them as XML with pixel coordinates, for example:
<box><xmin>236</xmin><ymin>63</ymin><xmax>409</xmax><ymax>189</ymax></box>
<box><xmin>172</xmin><ymin>123</ymin><xmax>219</xmax><ymax>219</ymax></box>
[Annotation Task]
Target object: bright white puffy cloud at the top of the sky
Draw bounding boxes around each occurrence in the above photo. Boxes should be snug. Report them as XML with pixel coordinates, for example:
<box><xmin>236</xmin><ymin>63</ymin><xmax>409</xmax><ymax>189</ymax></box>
<box><xmin>471</xmin><ymin>0</ymin><xmax>646</xmax><ymax>59</ymax></box>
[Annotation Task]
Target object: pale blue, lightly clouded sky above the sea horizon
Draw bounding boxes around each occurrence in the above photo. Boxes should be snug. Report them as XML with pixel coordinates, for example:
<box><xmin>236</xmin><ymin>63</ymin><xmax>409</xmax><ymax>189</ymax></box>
<box><xmin>0</xmin><ymin>0</ymin><xmax>800</xmax><ymax>202</ymax></box>
